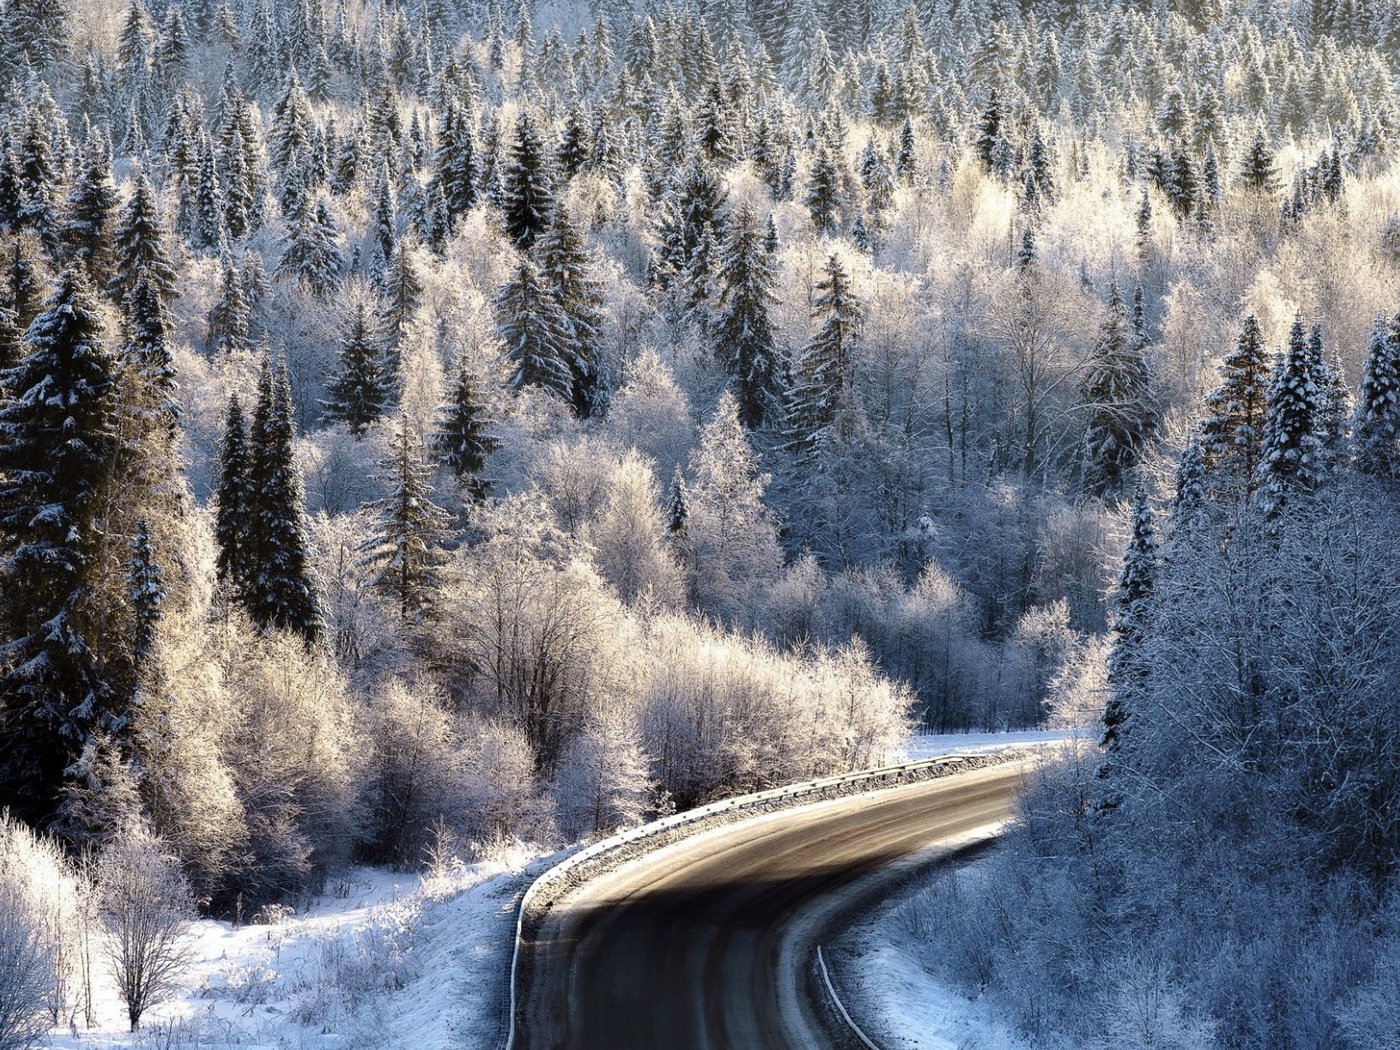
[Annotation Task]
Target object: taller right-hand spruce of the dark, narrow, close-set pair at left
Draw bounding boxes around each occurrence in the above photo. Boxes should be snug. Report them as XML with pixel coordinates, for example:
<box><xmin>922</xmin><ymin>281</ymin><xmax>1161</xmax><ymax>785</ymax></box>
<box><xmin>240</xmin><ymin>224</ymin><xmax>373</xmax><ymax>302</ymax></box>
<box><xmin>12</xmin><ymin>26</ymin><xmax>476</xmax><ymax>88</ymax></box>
<box><xmin>244</xmin><ymin>358</ymin><xmax>321</xmax><ymax>643</ymax></box>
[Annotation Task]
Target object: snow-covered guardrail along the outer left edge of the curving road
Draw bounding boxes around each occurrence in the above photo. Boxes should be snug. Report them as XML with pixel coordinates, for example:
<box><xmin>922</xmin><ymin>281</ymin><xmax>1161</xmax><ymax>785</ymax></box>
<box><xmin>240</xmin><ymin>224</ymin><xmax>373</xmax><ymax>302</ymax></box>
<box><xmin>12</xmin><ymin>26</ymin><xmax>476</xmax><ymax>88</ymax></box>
<box><xmin>505</xmin><ymin>752</ymin><xmax>1007</xmax><ymax>1050</ymax></box>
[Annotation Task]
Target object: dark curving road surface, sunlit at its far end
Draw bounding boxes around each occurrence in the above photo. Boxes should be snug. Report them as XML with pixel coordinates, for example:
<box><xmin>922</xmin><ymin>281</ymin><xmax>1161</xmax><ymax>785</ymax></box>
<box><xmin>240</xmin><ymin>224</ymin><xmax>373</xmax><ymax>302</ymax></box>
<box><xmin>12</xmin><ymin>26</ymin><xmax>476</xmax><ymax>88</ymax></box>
<box><xmin>514</xmin><ymin>763</ymin><xmax>1028</xmax><ymax>1050</ymax></box>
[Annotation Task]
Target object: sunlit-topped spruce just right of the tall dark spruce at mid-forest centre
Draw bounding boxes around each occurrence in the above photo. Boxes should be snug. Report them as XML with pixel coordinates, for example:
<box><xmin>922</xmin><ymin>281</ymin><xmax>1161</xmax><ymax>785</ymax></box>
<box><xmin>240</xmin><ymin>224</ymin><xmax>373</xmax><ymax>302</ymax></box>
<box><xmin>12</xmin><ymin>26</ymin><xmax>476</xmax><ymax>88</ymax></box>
<box><xmin>785</xmin><ymin>255</ymin><xmax>865</xmax><ymax>455</ymax></box>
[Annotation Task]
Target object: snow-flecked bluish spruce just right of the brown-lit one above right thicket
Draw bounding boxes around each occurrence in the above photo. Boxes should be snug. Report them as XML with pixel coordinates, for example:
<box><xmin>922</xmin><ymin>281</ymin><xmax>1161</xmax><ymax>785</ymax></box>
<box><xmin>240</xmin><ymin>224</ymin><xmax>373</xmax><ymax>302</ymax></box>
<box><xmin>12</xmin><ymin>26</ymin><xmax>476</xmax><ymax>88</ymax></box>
<box><xmin>1259</xmin><ymin>318</ymin><xmax>1324</xmax><ymax>514</ymax></box>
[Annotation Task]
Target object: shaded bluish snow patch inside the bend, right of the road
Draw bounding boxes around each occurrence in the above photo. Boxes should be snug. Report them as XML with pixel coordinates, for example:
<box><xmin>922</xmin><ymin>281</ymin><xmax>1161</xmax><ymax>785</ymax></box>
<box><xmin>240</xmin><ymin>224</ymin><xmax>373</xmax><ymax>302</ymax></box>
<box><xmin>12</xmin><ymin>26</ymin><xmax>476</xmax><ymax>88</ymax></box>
<box><xmin>832</xmin><ymin>862</ymin><xmax>1029</xmax><ymax>1050</ymax></box>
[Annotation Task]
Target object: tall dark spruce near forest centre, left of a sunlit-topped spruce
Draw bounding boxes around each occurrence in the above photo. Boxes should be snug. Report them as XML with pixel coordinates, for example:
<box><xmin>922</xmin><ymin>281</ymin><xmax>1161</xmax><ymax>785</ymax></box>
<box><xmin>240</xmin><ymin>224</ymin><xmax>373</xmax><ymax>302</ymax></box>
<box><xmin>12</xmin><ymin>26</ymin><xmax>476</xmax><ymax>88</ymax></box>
<box><xmin>714</xmin><ymin>204</ymin><xmax>780</xmax><ymax>430</ymax></box>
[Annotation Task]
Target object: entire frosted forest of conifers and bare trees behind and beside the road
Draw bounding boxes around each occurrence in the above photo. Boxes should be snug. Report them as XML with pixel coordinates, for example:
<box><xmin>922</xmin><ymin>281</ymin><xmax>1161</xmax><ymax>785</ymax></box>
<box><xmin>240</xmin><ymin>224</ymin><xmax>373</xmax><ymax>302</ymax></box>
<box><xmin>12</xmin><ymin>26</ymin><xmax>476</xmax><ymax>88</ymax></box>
<box><xmin>0</xmin><ymin>0</ymin><xmax>1400</xmax><ymax>1050</ymax></box>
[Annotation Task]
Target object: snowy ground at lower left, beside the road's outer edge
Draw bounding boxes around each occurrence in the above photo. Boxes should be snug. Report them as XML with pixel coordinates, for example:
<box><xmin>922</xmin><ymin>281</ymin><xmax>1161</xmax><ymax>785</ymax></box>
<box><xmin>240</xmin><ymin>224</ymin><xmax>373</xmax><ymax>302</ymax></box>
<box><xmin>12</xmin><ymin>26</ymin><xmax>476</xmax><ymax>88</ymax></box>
<box><xmin>48</xmin><ymin>848</ymin><xmax>545</xmax><ymax>1050</ymax></box>
